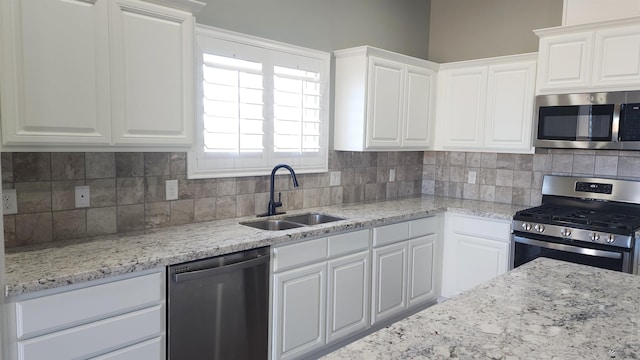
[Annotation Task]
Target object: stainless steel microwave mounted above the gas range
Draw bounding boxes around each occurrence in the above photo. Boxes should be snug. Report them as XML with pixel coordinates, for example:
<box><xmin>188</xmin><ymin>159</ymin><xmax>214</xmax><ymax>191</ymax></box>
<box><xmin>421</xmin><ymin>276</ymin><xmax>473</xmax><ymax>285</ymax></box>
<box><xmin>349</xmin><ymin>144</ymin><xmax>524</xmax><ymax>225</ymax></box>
<box><xmin>534</xmin><ymin>91</ymin><xmax>640</xmax><ymax>150</ymax></box>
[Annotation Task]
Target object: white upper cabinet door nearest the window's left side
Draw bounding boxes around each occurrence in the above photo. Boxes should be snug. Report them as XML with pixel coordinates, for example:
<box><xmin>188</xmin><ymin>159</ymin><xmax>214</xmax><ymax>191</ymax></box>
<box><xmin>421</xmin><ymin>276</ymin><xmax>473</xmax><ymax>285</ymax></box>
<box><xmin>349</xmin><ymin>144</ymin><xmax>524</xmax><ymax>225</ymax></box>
<box><xmin>109</xmin><ymin>0</ymin><xmax>194</xmax><ymax>145</ymax></box>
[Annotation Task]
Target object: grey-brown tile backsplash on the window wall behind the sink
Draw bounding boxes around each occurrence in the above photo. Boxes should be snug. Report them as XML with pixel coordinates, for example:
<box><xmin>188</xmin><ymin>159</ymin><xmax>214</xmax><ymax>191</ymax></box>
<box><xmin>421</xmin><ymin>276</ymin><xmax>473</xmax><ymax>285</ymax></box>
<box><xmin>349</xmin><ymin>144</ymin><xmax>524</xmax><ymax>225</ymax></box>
<box><xmin>1</xmin><ymin>151</ymin><xmax>423</xmax><ymax>248</ymax></box>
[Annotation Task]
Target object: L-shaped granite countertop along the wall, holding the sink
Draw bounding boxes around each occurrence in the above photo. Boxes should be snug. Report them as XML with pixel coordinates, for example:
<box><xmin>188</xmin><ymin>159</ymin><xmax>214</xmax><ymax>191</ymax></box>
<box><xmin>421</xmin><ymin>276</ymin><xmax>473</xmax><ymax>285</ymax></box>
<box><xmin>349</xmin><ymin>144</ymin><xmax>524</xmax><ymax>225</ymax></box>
<box><xmin>5</xmin><ymin>196</ymin><xmax>523</xmax><ymax>296</ymax></box>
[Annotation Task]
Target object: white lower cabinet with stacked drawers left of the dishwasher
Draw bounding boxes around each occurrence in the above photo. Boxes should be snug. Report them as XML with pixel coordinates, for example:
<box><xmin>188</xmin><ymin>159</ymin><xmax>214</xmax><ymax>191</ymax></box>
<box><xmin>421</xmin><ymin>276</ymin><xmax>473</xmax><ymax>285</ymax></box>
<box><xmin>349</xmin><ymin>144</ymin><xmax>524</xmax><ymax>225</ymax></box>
<box><xmin>9</xmin><ymin>270</ymin><xmax>166</xmax><ymax>360</ymax></box>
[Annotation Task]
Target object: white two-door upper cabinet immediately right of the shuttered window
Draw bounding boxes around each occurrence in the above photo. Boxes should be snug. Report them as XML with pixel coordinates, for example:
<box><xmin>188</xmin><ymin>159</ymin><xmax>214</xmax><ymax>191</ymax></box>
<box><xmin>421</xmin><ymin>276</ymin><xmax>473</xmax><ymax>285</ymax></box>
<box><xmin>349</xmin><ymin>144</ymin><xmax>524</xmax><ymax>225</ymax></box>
<box><xmin>334</xmin><ymin>46</ymin><xmax>437</xmax><ymax>151</ymax></box>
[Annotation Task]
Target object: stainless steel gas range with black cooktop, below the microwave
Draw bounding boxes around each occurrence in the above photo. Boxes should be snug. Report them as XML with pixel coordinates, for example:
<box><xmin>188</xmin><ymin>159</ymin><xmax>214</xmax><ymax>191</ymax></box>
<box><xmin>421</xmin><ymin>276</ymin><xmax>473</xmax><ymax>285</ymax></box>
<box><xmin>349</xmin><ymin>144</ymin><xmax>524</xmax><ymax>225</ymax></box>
<box><xmin>511</xmin><ymin>175</ymin><xmax>640</xmax><ymax>273</ymax></box>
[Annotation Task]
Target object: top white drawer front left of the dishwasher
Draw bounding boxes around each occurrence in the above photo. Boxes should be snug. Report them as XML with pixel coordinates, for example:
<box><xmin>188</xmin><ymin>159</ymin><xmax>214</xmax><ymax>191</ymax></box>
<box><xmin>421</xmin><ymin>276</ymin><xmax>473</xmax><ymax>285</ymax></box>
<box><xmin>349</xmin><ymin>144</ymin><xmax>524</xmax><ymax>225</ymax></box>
<box><xmin>16</xmin><ymin>272</ymin><xmax>165</xmax><ymax>339</ymax></box>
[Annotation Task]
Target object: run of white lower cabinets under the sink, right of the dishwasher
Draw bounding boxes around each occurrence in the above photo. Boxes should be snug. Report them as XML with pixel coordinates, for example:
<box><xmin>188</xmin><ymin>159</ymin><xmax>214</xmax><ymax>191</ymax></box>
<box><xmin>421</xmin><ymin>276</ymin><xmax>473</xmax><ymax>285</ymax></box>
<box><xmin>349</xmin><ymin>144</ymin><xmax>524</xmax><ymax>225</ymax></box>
<box><xmin>271</xmin><ymin>216</ymin><xmax>442</xmax><ymax>359</ymax></box>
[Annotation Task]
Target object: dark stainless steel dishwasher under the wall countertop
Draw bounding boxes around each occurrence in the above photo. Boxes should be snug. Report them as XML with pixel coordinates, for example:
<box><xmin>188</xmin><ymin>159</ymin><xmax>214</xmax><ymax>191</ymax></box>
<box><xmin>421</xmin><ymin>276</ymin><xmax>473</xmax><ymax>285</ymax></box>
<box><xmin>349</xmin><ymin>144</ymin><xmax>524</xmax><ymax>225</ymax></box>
<box><xmin>167</xmin><ymin>247</ymin><xmax>269</xmax><ymax>360</ymax></box>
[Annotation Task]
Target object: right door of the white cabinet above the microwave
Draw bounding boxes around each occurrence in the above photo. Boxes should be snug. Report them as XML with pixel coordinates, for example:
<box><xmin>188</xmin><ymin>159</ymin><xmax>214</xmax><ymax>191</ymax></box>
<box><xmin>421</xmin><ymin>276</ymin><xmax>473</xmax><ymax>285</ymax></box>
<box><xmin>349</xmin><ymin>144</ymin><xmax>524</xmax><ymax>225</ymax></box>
<box><xmin>591</xmin><ymin>25</ymin><xmax>640</xmax><ymax>88</ymax></box>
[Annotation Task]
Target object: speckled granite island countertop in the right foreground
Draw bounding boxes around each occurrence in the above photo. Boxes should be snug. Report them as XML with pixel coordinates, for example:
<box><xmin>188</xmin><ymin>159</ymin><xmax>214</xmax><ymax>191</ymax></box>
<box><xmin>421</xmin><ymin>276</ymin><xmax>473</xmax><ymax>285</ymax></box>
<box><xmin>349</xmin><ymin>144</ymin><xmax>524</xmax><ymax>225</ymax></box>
<box><xmin>325</xmin><ymin>258</ymin><xmax>640</xmax><ymax>360</ymax></box>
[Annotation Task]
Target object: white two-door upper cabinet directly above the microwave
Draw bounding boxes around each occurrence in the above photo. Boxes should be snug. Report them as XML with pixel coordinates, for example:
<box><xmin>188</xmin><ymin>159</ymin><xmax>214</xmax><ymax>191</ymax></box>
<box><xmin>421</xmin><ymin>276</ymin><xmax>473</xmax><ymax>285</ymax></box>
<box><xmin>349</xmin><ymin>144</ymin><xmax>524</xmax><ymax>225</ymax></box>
<box><xmin>535</xmin><ymin>18</ymin><xmax>640</xmax><ymax>94</ymax></box>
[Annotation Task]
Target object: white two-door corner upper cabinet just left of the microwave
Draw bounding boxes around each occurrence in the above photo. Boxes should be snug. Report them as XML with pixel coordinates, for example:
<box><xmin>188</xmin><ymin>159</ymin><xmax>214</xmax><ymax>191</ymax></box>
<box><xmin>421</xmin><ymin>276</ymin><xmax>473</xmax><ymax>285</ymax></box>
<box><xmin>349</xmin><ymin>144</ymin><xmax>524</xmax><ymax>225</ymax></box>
<box><xmin>435</xmin><ymin>53</ymin><xmax>537</xmax><ymax>153</ymax></box>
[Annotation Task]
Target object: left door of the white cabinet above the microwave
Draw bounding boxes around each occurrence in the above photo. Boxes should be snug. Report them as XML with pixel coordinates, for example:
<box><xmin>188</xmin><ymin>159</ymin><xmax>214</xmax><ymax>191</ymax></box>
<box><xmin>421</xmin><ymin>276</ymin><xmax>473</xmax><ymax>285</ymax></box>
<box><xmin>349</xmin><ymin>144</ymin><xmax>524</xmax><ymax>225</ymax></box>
<box><xmin>537</xmin><ymin>32</ymin><xmax>593</xmax><ymax>93</ymax></box>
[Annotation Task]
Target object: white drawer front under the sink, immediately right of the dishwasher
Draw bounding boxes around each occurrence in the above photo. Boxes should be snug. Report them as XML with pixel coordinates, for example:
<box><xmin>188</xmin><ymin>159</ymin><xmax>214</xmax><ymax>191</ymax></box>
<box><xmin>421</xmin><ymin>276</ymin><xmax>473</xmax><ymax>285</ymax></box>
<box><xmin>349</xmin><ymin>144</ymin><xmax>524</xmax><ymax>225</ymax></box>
<box><xmin>271</xmin><ymin>238</ymin><xmax>327</xmax><ymax>271</ymax></box>
